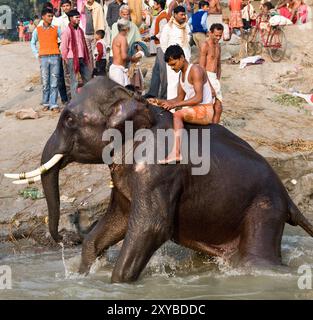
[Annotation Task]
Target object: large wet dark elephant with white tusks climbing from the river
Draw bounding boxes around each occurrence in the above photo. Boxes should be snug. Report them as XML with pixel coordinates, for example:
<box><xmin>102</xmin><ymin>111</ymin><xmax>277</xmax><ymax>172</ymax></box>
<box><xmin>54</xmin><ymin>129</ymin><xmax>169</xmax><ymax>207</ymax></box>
<box><xmin>6</xmin><ymin>77</ymin><xmax>313</xmax><ymax>282</ymax></box>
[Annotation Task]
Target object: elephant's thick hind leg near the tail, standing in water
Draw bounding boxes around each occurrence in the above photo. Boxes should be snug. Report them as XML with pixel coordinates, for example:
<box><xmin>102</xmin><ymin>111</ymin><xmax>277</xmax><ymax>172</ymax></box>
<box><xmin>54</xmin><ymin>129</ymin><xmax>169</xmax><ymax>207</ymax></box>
<box><xmin>239</xmin><ymin>202</ymin><xmax>286</xmax><ymax>267</ymax></box>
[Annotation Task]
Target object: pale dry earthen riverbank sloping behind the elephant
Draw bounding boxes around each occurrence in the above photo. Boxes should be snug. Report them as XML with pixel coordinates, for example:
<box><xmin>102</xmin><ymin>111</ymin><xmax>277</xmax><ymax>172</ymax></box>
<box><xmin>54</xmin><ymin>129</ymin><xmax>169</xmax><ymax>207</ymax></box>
<box><xmin>0</xmin><ymin>18</ymin><xmax>313</xmax><ymax>256</ymax></box>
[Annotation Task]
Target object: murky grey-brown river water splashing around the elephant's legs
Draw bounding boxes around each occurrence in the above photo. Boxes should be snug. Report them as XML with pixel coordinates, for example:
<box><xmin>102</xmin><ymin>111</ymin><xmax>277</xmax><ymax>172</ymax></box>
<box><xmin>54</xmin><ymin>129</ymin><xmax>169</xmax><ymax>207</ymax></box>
<box><xmin>0</xmin><ymin>227</ymin><xmax>313</xmax><ymax>300</ymax></box>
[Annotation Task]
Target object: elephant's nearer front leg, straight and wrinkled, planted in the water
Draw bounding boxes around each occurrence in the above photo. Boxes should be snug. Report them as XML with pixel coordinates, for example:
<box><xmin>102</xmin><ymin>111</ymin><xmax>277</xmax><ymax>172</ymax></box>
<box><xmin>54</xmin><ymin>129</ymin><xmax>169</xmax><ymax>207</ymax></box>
<box><xmin>112</xmin><ymin>181</ymin><xmax>176</xmax><ymax>282</ymax></box>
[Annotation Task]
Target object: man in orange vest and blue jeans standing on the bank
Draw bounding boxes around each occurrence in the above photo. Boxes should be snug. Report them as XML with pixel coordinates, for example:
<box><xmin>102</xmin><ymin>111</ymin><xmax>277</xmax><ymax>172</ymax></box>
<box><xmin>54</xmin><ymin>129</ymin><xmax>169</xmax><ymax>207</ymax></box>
<box><xmin>31</xmin><ymin>9</ymin><xmax>61</xmax><ymax>112</ymax></box>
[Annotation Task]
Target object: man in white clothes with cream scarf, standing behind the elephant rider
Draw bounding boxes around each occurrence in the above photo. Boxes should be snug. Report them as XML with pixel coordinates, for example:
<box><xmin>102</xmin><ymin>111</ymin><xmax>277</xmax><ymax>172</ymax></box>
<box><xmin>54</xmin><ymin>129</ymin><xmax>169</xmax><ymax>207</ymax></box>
<box><xmin>160</xmin><ymin>6</ymin><xmax>191</xmax><ymax>100</ymax></box>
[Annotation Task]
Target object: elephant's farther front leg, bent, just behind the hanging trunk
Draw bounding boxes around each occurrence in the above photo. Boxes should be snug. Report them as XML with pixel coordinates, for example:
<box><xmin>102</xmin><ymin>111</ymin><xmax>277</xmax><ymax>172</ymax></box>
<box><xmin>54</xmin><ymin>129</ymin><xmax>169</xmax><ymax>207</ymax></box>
<box><xmin>79</xmin><ymin>192</ymin><xmax>129</xmax><ymax>273</ymax></box>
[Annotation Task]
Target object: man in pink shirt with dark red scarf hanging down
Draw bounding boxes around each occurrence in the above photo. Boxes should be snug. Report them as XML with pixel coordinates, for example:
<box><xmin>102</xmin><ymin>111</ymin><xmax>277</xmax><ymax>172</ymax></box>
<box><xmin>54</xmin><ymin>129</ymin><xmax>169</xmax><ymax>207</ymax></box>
<box><xmin>61</xmin><ymin>9</ymin><xmax>91</xmax><ymax>98</ymax></box>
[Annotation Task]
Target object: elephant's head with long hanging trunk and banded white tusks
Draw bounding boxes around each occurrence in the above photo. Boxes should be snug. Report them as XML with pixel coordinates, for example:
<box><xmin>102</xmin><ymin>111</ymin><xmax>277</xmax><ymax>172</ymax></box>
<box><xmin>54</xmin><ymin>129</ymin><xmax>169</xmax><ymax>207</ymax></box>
<box><xmin>5</xmin><ymin>77</ymin><xmax>154</xmax><ymax>242</ymax></box>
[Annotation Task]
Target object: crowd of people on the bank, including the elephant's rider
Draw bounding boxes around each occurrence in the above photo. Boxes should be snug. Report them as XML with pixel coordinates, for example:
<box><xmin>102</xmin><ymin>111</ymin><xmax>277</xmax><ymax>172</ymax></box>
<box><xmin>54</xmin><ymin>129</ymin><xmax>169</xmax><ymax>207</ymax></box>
<box><xmin>24</xmin><ymin>0</ymin><xmax>307</xmax><ymax>146</ymax></box>
